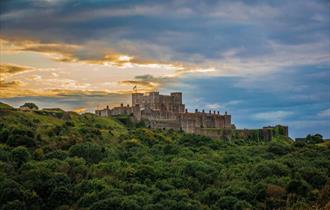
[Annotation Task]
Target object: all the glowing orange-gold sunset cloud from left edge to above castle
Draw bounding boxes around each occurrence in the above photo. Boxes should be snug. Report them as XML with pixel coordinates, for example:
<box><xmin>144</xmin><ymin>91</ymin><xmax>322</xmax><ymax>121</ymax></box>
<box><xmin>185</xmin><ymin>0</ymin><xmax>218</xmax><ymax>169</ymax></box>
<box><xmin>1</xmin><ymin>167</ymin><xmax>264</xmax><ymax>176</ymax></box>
<box><xmin>0</xmin><ymin>37</ymin><xmax>219</xmax><ymax>97</ymax></box>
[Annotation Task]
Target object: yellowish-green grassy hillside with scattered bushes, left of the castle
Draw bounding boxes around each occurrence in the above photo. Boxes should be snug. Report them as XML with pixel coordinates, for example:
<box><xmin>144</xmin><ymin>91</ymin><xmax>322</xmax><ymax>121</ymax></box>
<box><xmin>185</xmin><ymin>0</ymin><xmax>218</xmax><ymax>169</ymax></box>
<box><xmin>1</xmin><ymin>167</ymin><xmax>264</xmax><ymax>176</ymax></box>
<box><xmin>0</xmin><ymin>106</ymin><xmax>127</xmax><ymax>149</ymax></box>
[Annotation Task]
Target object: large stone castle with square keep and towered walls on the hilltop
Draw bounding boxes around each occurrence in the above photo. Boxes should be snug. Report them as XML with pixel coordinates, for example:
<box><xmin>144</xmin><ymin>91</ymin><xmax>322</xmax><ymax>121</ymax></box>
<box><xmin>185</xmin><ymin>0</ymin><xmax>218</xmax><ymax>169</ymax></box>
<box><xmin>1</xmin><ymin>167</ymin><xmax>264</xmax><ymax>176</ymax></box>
<box><xmin>95</xmin><ymin>92</ymin><xmax>288</xmax><ymax>140</ymax></box>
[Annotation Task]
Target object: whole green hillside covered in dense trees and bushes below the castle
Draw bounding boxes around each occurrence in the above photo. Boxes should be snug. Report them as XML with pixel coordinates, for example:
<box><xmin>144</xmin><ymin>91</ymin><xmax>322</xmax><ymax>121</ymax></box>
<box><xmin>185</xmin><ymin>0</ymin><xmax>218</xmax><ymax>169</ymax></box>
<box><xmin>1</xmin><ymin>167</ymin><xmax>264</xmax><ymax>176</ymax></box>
<box><xmin>0</xmin><ymin>102</ymin><xmax>330</xmax><ymax>210</ymax></box>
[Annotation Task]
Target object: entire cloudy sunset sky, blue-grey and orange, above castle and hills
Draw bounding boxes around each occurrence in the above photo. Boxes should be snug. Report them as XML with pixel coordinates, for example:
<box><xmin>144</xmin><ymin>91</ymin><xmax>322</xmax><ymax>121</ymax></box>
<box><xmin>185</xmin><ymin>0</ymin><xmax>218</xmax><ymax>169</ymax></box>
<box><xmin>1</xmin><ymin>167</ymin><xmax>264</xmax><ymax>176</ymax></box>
<box><xmin>0</xmin><ymin>0</ymin><xmax>330</xmax><ymax>138</ymax></box>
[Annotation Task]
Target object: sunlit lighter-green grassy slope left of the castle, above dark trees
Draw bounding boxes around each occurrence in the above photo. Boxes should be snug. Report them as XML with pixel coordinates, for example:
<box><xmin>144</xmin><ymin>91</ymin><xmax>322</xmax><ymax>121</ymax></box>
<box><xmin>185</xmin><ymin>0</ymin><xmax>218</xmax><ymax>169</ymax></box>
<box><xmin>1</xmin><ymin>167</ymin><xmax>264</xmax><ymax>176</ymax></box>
<box><xmin>0</xmin><ymin>103</ymin><xmax>128</xmax><ymax>146</ymax></box>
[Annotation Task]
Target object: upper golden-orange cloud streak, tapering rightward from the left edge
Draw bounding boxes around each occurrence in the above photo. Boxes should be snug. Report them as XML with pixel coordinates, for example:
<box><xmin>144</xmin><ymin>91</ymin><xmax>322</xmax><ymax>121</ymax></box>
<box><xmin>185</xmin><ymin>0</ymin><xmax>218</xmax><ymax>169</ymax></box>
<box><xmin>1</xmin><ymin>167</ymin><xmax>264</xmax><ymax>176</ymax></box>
<box><xmin>0</xmin><ymin>38</ymin><xmax>186</xmax><ymax>69</ymax></box>
